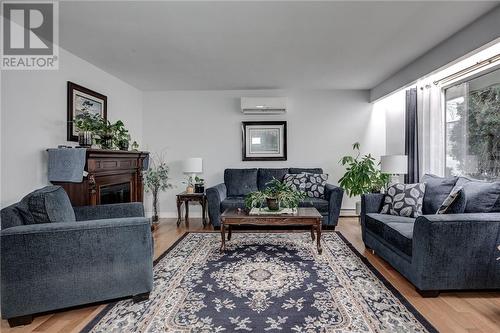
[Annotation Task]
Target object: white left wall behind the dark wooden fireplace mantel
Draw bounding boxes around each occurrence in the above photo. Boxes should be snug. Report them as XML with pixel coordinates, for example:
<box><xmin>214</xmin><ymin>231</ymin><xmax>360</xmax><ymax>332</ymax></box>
<box><xmin>1</xmin><ymin>49</ymin><xmax>142</xmax><ymax>207</ymax></box>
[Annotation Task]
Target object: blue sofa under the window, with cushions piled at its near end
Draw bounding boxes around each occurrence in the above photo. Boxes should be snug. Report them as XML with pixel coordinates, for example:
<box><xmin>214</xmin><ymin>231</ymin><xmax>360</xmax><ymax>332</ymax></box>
<box><xmin>361</xmin><ymin>175</ymin><xmax>500</xmax><ymax>297</ymax></box>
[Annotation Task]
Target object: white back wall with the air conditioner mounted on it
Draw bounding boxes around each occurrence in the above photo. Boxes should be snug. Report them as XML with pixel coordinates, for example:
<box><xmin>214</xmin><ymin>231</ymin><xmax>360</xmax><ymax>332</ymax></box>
<box><xmin>143</xmin><ymin>90</ymin><xmax>386</xmax><ymax>216</ymax></box>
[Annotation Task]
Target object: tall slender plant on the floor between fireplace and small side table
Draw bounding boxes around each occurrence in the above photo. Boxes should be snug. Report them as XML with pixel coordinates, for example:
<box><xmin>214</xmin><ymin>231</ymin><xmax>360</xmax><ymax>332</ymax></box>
<box><xmin>143</xmin><ymin>157</ymin><xmax>172</xmax><ymax>222</ymax></box>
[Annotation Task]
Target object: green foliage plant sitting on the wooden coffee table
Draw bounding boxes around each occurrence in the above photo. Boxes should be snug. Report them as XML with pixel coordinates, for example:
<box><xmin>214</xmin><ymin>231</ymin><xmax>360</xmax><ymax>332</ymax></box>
<box><xmin>245</xmin><ymin>178</ymin><xmax>306</xmax><ymax>211</ymax></box>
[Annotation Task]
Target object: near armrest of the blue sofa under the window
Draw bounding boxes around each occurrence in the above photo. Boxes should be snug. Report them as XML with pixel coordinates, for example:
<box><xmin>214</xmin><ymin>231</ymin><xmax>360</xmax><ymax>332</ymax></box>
<box><xmin>412</xmin><ymin>213</ymin><xmax>500</xmax><ymax>290</ymax></box>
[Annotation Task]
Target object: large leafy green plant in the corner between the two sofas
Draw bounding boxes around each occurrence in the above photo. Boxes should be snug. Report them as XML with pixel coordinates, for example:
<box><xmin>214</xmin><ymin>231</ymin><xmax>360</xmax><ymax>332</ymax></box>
<box><xmin>339</xmin><ymin>142</ymin><xmax>390</xmax><ymax>215</ymax></box>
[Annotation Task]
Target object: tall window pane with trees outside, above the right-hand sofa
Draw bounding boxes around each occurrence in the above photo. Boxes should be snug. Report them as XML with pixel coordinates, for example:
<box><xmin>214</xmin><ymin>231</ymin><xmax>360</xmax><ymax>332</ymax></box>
<box><xmin>443</xmin><ymin>69</ymin><xmax>500</xmax><ymax>180</ymax></box>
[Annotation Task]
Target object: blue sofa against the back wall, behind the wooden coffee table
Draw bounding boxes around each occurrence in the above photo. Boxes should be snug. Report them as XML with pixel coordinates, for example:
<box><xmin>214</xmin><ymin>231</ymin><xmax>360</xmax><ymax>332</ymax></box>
<box><xmin>206</xmin><ymin>168</ymin><xmax>344</xmax><ymax>228</ymax></box>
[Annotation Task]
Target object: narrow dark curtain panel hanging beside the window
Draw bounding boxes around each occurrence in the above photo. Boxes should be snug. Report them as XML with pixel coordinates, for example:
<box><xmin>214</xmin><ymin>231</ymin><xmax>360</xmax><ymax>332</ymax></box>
<box><xmin>405</xmin><ymin>88</ymin><xmax>420</xmax><ymax>184</ymax></box>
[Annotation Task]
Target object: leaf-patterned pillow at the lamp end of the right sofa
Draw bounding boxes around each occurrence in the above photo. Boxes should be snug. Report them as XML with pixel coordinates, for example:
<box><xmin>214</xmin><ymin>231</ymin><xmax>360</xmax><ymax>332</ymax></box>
<box><xmin>380</xmin><ymin>183</ymin><xmax>425</xmax><ymax>217</ymax></box>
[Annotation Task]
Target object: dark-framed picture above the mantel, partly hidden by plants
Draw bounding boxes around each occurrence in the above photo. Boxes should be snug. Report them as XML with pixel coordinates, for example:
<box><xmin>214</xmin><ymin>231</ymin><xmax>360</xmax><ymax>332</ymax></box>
<box><xmin>67</xmin><ymin>81</ymin><xmax>108</xmax><ymax>141</ymax></box>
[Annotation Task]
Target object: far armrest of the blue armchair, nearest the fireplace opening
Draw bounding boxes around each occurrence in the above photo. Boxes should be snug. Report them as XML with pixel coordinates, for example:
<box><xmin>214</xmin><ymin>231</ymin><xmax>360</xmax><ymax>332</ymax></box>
<box><xmin>73</xmin><ymin>202</ymin><xmax>144</xmax><ymax>221</ymax></box>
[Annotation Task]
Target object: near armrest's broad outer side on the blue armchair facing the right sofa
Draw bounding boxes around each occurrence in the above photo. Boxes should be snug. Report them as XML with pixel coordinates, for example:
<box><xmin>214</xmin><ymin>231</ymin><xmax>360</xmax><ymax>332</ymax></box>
<box><xmin>0</xmin><ymin>217</ymin><xmax>153</xmax><ymax>318</ymax></box>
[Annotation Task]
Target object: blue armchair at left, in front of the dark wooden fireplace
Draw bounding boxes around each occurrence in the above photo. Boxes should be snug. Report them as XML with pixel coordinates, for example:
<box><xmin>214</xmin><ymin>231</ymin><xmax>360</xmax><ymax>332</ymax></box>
<box><xmin>0</xmin><ymin>186</ymin><xmax>153</xmax><ymax>326</ymax></box>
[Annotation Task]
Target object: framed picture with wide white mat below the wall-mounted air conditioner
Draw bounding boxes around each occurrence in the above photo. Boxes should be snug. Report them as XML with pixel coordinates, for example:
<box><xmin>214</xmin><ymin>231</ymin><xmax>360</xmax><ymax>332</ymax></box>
<box><xmin>241</xmin><ymin>121</ymin><xmax>286</xmax><ymax>161</ymax></box>
